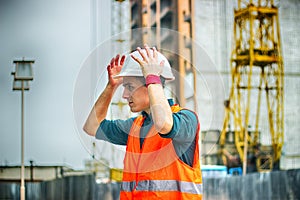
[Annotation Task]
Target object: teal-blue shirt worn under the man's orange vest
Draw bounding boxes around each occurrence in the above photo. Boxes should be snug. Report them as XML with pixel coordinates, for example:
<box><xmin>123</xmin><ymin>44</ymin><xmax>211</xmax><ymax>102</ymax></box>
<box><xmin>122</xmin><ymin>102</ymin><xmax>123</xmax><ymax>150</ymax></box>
<box><xmin>96</xmin><ymin>100</ymin><xmax>198</xmax><ymax>166</ymax></box>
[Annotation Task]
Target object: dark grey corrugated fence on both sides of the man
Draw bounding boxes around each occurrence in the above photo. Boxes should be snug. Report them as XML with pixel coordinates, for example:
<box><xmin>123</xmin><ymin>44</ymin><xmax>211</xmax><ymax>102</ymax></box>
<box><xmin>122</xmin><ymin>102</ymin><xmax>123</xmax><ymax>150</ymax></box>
<box><xmin>0</xmin><ymin>169</ymin><xmax>300</xmax><ymax>200</ymax></box>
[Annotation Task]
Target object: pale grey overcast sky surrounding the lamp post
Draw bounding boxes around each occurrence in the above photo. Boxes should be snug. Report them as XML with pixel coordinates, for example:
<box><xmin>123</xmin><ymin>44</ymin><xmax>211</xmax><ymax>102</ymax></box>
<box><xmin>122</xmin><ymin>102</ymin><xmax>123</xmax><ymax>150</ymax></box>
<box><xmin>0</xmin><ymin>0</ymin><xmax>91</xmax><ymax>168</ymax></box>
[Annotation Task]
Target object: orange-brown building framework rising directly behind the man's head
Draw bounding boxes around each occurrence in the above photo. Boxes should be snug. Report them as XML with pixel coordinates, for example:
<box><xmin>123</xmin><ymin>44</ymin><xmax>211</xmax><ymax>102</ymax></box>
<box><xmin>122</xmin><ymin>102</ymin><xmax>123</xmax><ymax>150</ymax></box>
<box><xmin>130</xmin><ymin>0</ymin><xmax>197</xmax><ymax>111</ymax></box>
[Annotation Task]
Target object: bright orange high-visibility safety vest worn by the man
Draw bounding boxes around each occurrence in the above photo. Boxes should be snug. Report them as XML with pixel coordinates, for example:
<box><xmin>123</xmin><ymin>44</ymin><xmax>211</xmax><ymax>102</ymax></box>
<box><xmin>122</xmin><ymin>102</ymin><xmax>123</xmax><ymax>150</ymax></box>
<box><xmin>120</xmin><ymin>105</ymin><xmax>203</xmax><ymax>200</ymax></box>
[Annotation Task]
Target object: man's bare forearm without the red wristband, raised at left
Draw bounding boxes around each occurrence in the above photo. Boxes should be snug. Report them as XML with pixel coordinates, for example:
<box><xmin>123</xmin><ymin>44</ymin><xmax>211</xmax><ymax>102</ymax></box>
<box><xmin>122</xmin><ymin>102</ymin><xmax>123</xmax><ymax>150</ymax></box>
<box><xmin>83</xmin><ymin>84</ymin><xmax>116</xmax><ymax>136</ymax></box>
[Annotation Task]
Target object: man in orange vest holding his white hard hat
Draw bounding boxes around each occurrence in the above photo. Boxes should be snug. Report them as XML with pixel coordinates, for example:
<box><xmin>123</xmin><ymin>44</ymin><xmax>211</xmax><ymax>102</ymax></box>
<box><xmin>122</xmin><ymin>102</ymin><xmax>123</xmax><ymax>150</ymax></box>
<box><xmin>83</xmin><ymin>45</ymin><xmax>202</xmax><ymax>199</ymax></box>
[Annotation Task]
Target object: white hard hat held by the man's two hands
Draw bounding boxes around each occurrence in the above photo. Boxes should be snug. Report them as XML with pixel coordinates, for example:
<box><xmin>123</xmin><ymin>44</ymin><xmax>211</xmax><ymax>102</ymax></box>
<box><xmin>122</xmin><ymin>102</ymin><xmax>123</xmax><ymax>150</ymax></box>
<box><xmin>114</xmin><ymin>49</ymin><xmax>175</xmax><ymax>80</ymax></box>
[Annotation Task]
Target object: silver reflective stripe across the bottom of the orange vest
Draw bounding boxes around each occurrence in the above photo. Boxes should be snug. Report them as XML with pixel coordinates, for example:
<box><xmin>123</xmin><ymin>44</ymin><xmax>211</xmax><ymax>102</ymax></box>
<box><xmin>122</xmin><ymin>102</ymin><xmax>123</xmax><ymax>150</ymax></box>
<box><xmin>121</xmin><ymin>180</ymin><xmax>203</xmax><ymax>194</ymax></box>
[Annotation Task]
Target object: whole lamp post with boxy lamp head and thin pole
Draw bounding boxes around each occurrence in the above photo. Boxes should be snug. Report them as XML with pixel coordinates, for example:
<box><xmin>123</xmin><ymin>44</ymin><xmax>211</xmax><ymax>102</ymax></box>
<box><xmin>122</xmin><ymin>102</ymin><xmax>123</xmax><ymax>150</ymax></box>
<box><xmin>11</xmin><ymin>58</ymin><xmax>34</xmax><ymax>200</ymax></box>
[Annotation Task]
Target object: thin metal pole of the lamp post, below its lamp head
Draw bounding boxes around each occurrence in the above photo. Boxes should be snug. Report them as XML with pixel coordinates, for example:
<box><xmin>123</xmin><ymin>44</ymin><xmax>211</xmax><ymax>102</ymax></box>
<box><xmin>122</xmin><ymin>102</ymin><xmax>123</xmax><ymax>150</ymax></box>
<box><xmin>20</xmin><ymin>80</ymin><xmax>25</xmax><ymax>200</ymax></box>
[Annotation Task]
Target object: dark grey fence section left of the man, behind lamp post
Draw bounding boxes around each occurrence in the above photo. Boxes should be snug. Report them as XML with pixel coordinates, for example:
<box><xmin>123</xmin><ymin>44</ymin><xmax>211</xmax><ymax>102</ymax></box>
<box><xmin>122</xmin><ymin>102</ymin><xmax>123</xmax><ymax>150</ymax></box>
<box><xmin>0</xmin><ymin>175</ymin><xmax>120</xmax><ymax>200</ymax></box>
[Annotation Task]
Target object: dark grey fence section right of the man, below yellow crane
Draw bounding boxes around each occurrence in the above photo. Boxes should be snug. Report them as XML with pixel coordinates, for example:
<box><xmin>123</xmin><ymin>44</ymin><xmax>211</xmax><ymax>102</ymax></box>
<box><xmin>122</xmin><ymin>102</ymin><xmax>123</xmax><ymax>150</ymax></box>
<box><xmin>203</xmin><ymin>169</ymin><xmax>300</xmax><ymax>200</ymax></box>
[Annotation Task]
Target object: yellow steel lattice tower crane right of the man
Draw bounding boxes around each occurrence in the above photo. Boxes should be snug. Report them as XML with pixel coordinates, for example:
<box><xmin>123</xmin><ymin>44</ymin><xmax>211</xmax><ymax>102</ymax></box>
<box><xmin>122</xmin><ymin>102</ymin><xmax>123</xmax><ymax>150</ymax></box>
<box><xmin>219</xmin><ymin>0</ymin><xmax>284</xmax><ymax>174</ymax></box>
